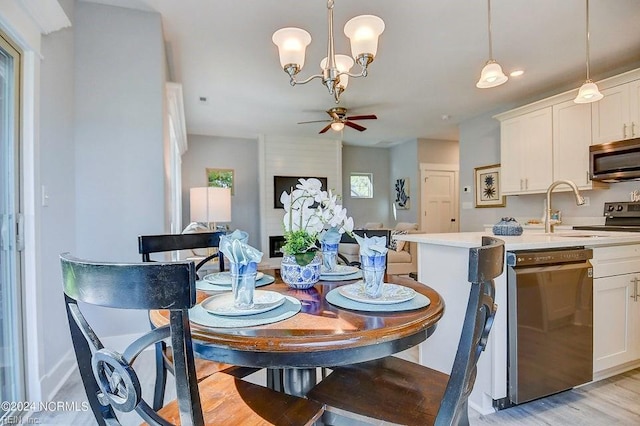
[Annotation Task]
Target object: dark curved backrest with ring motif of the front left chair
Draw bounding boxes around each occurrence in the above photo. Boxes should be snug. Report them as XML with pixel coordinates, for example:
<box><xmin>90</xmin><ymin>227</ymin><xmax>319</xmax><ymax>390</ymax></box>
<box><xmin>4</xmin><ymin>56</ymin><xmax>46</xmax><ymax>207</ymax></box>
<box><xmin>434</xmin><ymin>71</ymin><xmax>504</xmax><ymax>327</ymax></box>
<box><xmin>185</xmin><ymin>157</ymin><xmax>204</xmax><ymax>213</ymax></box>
<box><xmin>60</xmin><ymin>253</ymin><xmax>204</xmax><ymax>425</ymax></box>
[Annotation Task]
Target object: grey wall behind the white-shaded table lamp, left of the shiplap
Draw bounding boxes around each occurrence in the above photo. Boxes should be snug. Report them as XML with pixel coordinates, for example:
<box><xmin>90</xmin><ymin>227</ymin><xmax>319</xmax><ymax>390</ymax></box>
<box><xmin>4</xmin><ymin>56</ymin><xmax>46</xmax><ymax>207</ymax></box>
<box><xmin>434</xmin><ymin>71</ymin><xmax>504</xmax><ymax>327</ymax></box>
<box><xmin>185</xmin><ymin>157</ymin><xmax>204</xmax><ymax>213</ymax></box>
<box><xmin>182</xmin><ymin>135</ymin><xmax>264</xmax><ymax>246</ymax></box>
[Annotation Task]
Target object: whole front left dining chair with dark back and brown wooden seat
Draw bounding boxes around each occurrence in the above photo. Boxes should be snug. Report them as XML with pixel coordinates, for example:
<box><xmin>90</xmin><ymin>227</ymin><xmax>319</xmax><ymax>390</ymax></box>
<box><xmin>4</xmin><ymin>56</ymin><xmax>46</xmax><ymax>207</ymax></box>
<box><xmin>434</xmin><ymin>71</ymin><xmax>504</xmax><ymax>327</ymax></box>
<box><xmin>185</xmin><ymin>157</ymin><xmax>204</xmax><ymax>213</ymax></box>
<box><xmin>60</xmin><ymin>253</ymin><xmax>324</xmax><ymax>426</ymax></box>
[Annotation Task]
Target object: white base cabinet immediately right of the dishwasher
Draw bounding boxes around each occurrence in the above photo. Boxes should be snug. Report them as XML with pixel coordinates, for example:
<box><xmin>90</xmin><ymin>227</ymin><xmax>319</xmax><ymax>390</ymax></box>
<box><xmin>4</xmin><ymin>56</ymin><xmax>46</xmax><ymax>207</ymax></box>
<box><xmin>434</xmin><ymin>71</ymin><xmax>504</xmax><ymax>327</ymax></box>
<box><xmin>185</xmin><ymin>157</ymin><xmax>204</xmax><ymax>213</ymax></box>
<box><xmin>592</xmin><ymin>245</ymin><xmax>640</xmax><ymax>373</ymax></box>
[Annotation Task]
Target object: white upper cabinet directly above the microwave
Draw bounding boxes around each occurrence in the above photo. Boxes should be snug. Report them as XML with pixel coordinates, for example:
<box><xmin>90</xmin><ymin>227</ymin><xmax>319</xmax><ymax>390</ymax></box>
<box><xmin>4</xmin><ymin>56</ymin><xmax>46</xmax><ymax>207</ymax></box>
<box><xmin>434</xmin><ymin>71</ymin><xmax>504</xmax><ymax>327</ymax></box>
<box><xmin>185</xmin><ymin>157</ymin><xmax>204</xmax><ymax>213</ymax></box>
<box><xmin>592</xmin><ymin>80</ymin><xmax>640</xmax><ymax>144</ymax></box>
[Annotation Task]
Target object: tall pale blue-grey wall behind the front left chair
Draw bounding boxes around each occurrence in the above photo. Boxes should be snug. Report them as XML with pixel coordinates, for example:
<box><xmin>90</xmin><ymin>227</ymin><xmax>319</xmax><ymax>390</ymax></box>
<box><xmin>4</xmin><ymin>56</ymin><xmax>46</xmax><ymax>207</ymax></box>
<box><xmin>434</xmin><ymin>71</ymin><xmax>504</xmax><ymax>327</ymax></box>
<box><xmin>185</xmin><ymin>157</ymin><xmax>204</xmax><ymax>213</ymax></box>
<box><xmin>75</xmin><ymin>2</ymin><xmax>165</xmax><ymax>336</ymax></box>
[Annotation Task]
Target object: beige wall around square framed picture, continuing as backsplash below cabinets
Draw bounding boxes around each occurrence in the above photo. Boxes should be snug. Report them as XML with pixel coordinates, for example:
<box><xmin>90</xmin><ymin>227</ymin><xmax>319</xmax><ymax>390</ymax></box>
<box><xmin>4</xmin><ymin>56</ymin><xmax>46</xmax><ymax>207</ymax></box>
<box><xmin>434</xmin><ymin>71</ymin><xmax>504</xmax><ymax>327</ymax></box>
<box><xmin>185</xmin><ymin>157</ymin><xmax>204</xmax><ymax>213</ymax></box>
<box><xmin>460</xmin><ymin>112</ymin><xmax>640</xmax><ymax>231</ymax></box>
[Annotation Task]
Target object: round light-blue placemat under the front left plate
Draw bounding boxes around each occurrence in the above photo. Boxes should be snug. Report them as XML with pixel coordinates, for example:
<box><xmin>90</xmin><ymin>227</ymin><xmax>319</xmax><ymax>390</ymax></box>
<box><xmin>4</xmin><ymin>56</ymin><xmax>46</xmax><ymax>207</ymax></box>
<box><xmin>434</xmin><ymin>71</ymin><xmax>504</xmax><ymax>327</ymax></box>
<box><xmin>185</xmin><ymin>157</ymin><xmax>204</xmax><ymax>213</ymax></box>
<box><xmin>189</xmin><ymin>296</ymin><xmax>302</xmax><ymax>328</ymax></box>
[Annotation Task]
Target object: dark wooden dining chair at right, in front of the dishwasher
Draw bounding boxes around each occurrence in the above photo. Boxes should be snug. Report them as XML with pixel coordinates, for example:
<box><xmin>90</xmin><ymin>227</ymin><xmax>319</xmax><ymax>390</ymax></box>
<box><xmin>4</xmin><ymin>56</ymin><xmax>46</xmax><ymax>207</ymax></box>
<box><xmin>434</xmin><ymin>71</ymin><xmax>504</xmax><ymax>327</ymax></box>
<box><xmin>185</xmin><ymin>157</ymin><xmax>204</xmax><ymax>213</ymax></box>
<box><xmin>307</xmin><ymin>237</ymin><xmax>504</xmax><ymax>426</ymax></box>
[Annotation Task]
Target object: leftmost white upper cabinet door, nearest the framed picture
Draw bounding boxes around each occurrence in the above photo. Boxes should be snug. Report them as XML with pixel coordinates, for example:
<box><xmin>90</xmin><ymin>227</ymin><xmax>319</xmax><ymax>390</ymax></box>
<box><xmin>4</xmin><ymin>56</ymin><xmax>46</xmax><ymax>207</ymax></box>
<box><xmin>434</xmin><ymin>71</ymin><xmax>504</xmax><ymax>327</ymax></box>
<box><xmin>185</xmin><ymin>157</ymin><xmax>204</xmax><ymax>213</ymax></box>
<box><xmin>500</xmin><ymin>107</ymin><xmax>553</xmax><ymax>195</ymax></box>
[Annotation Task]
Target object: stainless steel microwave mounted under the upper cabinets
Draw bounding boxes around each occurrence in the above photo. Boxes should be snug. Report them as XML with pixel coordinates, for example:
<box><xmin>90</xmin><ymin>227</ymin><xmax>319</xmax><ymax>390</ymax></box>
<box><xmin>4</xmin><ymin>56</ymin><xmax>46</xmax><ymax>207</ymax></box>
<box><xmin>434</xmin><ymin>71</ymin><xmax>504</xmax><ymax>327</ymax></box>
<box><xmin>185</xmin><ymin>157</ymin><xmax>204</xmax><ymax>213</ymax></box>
<box><xmin>589</xmin><ymin>138</ymin><xmax>640</xmax><ymax>182</ymax></box>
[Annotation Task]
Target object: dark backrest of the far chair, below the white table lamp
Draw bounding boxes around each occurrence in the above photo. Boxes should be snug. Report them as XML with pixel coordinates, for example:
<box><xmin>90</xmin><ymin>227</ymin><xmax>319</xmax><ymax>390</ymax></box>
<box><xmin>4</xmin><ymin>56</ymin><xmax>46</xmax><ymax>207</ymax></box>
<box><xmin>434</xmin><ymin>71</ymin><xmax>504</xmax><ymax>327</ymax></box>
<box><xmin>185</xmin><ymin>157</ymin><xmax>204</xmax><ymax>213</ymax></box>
<box><xmin>138</xmin><ymin>232</ymin><xmax>225</xmax><ymax>272</ymax></box>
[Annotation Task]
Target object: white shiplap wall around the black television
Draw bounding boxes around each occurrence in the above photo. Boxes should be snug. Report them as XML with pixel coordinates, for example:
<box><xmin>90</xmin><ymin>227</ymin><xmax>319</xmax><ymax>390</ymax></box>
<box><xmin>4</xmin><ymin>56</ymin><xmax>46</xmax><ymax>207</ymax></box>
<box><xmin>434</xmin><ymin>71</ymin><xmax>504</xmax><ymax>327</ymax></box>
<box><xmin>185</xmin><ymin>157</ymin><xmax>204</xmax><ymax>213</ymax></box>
<box><xmin>258</xmin><ymin>135</ymin><xmax>342</xmax><ymax>265</ymax></box>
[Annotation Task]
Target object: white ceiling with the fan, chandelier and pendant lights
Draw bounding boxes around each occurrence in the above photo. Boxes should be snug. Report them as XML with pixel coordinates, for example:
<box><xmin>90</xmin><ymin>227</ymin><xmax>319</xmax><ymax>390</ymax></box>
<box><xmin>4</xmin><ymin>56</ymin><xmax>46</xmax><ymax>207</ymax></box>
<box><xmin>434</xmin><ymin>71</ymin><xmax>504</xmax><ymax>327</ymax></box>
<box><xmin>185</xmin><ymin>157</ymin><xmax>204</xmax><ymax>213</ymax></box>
<box><xmin>82</xmin><ymin>0</ymin><xmax>640</xmax><ymax>146</ymax></box>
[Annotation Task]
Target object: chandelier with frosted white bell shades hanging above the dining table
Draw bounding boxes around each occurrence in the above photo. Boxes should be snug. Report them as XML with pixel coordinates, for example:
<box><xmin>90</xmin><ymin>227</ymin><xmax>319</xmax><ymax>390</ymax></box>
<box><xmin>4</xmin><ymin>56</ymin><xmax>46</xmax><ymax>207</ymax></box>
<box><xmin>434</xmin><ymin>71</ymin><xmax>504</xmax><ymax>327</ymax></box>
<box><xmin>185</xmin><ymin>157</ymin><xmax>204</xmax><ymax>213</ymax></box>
<box><xmin>271</xmin><ymin>0</ymin><xmax>384</xmax><ymax>103</ymax></box>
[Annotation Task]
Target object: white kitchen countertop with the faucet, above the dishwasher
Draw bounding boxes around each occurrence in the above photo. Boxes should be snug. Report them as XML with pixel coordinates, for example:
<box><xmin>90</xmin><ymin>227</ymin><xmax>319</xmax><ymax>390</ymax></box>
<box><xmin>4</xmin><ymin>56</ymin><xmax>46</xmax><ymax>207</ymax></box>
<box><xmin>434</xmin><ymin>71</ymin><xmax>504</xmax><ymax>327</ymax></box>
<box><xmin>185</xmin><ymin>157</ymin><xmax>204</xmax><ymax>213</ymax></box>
<box><xmin>395</xmin><ymin>230</ymin><xmax>640</xmax><ymax>250</ymax></box>
